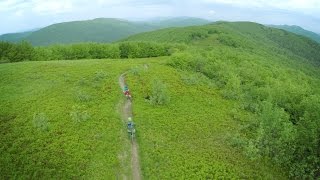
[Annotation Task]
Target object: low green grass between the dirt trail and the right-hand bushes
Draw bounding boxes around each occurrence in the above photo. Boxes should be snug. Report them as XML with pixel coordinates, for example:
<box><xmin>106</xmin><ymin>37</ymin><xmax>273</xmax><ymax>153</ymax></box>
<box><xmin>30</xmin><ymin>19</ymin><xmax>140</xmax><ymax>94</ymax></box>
<box><xmin>128</xmin><ymin>64</ymin><xmax>284</xmax><ymax>179</ymax></box>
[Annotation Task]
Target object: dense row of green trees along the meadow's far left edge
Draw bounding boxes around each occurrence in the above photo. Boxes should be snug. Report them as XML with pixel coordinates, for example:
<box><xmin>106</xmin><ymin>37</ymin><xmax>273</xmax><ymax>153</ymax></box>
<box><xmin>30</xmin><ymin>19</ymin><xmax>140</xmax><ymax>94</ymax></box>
<box><xmin>0</xmin><ymin>41</ymin><xmax>178</xmax><ymax>62</ymax></box>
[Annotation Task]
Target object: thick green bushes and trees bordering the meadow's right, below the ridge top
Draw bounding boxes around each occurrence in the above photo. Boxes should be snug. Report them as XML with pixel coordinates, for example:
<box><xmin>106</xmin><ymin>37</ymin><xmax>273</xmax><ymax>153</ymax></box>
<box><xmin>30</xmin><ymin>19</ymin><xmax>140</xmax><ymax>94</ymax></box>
<box><xmin>169</xmin><ymin>48</ymin><xmax>320</xmax><ymax>179</ymax></box>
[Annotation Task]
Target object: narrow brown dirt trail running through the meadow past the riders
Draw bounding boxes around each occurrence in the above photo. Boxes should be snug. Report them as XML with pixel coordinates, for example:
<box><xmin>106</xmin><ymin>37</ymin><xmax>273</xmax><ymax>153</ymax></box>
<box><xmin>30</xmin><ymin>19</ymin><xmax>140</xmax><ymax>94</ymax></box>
<box><xmin>119</xmin><ymin>73</ymin><xmax>141</xmax><ymax>180</ymax></box>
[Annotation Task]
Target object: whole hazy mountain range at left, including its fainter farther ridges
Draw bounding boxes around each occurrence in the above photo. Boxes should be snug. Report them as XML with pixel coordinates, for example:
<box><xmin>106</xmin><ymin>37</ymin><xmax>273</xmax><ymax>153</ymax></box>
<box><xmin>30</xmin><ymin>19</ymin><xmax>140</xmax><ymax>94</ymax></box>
<box><xmin>0</xmin><ymin>17</ymin><xmax>209</xmax><ymax>46</ymax></box>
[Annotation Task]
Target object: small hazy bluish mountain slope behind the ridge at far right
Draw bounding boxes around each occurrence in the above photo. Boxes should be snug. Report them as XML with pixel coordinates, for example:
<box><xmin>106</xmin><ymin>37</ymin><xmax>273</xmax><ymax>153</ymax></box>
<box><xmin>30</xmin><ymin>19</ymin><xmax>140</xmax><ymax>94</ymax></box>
<box><xmin>270</xmin><ymin>25</ymin><xmax>320</xmax><ymax>43</ymax></box>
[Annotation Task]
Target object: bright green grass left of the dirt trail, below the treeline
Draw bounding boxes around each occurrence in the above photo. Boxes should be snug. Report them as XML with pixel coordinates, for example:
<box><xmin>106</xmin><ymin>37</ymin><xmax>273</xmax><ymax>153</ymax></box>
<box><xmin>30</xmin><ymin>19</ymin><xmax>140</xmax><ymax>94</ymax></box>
<box><xmin>0</xmin><ymin>60</ymin><xmax>160</xmax><ymax>179</ymax></box>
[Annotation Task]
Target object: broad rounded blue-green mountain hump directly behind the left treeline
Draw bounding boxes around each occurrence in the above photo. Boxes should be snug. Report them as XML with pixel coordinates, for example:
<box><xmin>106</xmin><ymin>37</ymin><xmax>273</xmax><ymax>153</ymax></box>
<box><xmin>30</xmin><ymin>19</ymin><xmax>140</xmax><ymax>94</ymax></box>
<box><xmin>26</xmin><ymin>18</ymin><xmax>153</xmax><ymax>45</ymax></box>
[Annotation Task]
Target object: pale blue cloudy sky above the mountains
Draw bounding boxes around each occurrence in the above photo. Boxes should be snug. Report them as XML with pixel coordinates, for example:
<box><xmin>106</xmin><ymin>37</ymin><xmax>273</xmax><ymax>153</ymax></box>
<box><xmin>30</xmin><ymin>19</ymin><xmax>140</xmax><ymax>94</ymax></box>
<box><xmin>0</xmin><ymin>0</ymin><xmax>320</xmax><ymax>34</ymax></box>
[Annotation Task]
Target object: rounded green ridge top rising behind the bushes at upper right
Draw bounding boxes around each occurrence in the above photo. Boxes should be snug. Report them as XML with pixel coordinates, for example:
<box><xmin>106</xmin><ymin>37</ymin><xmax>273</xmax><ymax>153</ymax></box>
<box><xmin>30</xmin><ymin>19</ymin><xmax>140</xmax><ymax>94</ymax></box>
<box><xmin>123</xmin><ymin>22</ymin><xmax>320</xmax><ymax>64</ymax></box>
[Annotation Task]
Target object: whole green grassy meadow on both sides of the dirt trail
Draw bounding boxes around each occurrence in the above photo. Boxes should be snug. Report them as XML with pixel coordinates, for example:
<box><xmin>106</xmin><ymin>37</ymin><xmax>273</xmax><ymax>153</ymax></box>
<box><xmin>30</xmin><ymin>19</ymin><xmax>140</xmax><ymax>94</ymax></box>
<box><xmin>0</xmin><ymin>57</ymin><xmax>282</xmax><ymax>179</ymax></box>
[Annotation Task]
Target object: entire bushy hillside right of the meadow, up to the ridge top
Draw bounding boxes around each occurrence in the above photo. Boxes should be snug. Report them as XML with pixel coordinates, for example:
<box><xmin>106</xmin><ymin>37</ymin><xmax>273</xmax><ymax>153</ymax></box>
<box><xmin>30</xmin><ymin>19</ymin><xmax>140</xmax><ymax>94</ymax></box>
<box><xmin>123</xmin><ymin>22</ymin><xmax>320</xmax><ymax>178</ymax></box>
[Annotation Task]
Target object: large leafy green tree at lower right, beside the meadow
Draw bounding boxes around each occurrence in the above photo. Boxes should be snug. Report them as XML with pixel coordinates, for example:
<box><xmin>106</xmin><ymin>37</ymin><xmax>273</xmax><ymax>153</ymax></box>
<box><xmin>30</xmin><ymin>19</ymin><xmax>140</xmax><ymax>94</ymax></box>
<box><xmin>256</xmin><ymin>101</ymin><xmax>296</xmax><ymax>167</ymax></box>
